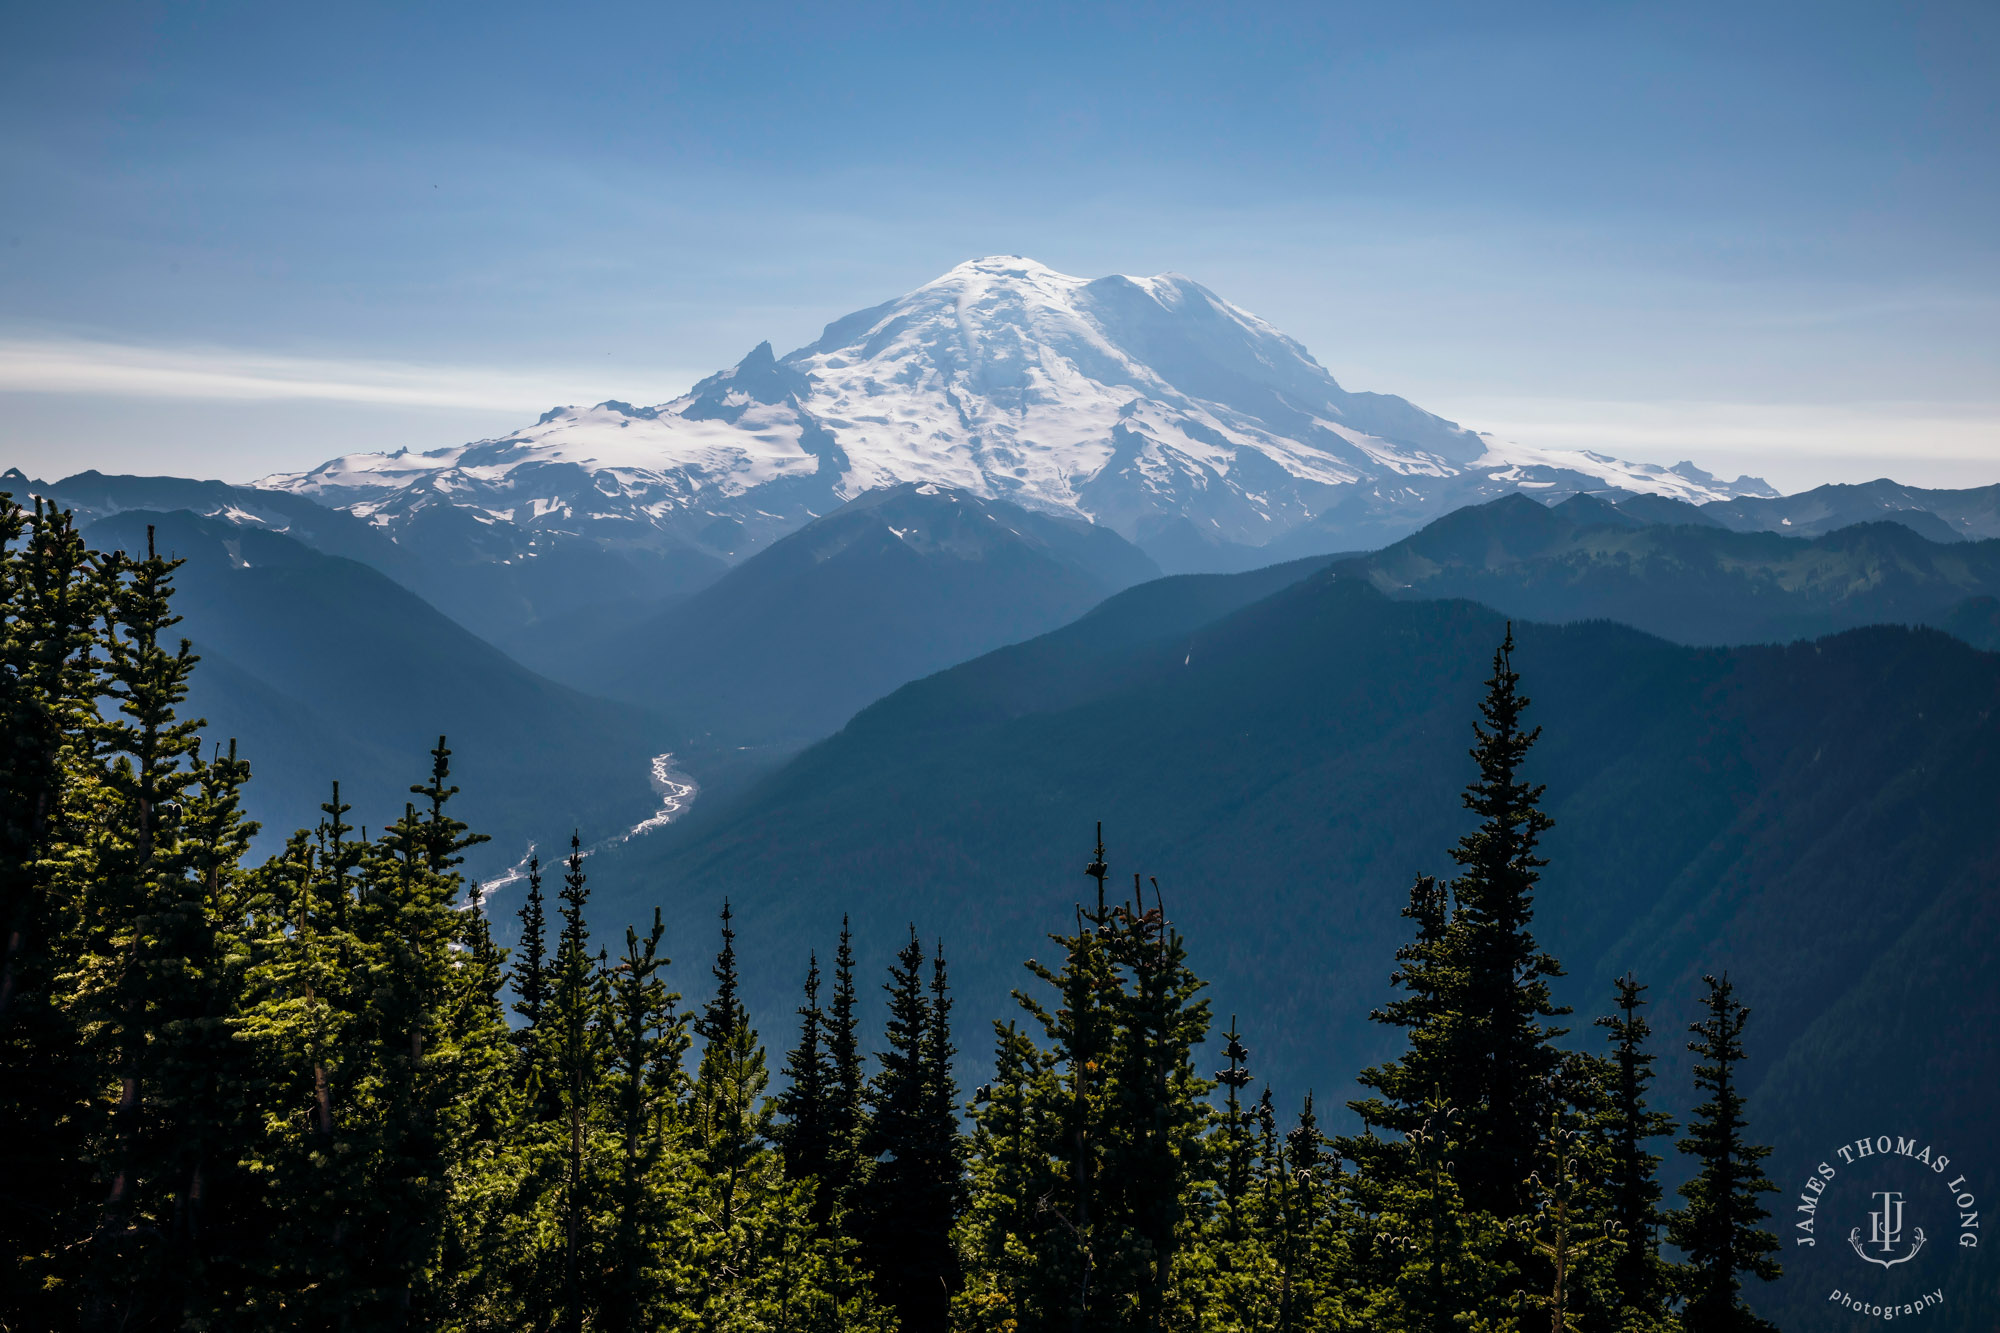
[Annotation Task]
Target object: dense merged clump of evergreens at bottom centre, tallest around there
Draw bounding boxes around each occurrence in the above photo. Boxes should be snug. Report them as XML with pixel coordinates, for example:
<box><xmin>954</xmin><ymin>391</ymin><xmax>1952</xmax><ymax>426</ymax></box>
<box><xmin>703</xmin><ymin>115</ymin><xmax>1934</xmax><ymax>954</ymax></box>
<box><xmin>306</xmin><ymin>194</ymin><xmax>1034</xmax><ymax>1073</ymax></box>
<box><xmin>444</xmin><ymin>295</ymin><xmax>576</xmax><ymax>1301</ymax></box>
<box><xmin>958</xmin><ymin>841</ymin><xmax>1214</xmax><ymax>1329</ymax></box>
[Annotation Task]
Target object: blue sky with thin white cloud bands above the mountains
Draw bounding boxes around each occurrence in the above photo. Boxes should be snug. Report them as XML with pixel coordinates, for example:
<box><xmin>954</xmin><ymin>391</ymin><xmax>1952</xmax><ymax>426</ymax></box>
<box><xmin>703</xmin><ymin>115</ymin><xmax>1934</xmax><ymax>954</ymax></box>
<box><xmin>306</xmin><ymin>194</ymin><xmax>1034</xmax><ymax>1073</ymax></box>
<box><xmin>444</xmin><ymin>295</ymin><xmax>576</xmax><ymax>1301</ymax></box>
<box><xmin>0</xmin><ymin>2</ymin><xmax>2000</xmax><ymax>488</ymax></box>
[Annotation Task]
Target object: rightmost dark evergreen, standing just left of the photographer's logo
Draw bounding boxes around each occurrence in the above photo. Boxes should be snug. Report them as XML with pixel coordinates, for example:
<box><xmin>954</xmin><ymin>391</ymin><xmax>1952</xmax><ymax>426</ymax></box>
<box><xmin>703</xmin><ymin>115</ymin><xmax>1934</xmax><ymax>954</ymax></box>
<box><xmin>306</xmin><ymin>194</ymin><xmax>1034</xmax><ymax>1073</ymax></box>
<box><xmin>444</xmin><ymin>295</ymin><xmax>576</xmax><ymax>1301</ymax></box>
<box><xmin>1668</xmin><ymin>977</ymin><xmax>1780</xmax><ymax>1333</ymax></box>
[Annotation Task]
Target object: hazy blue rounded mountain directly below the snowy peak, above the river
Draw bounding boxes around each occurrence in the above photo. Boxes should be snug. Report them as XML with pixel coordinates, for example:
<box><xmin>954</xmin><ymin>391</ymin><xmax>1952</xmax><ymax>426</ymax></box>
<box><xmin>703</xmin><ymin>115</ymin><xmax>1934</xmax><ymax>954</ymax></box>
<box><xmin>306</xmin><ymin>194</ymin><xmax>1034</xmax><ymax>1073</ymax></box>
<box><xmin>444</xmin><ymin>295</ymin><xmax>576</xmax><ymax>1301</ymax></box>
<box><xmin>596</xmin><ymin>484</ymin><xmax>1158</xmax><ymax>745</ymax></box>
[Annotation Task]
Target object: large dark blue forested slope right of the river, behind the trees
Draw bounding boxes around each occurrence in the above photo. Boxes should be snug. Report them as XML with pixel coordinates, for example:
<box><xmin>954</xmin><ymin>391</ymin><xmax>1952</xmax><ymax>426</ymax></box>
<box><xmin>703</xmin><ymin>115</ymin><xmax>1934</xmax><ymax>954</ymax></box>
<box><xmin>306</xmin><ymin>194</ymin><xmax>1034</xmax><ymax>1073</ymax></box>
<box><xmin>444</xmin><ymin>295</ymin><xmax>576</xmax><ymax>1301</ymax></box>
<box><xmin>606</xmin><ymin>574</ymin><xmax>2000</xmax><ymax>1328</ymax></box>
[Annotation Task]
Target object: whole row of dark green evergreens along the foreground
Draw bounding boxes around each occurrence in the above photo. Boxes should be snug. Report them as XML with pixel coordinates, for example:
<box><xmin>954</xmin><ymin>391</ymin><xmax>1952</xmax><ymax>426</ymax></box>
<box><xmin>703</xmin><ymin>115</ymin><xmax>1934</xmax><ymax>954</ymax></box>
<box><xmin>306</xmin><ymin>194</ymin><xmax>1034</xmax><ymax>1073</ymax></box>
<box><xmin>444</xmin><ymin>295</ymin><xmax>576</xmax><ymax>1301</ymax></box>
<box><xmin>0</xmin><ymin>496</ymin><xmax>1778</xmax><ymax>1333</ymax></box>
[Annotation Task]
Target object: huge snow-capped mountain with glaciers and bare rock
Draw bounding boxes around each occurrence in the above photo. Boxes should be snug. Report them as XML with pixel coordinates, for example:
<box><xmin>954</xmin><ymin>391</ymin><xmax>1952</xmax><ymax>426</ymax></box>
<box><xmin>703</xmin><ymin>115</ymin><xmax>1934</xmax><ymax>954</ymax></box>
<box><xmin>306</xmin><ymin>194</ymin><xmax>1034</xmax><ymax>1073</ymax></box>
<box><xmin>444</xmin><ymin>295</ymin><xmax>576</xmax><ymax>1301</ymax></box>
<box><xmin>256</xmin><ymin>256</ymin><xmax>1776</xmax><ymax>560</ymax></box>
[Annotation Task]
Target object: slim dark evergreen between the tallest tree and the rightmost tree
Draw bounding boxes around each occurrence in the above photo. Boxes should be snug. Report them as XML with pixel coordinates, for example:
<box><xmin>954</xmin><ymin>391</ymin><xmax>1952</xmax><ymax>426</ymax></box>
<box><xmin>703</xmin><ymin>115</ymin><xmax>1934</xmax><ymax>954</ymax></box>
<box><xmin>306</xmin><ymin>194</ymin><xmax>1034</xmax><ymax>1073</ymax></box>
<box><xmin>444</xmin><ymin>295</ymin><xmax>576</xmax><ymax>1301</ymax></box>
<box><xmin>1598</xmin><ymin>975</ymin><xmax>1674</xmax><ymax>1323</ymax></box>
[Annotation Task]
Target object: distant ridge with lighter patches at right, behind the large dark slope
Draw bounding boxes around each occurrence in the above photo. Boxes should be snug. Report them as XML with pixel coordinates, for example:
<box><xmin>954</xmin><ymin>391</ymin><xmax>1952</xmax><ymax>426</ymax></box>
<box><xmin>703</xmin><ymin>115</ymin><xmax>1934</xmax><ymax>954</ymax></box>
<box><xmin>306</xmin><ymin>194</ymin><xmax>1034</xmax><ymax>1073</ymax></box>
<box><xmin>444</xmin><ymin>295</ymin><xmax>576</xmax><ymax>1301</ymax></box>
<box><xmin>1338</xmin><ymin>494</ymin><xmax>2000</xmax><ymax>644</ymax></box>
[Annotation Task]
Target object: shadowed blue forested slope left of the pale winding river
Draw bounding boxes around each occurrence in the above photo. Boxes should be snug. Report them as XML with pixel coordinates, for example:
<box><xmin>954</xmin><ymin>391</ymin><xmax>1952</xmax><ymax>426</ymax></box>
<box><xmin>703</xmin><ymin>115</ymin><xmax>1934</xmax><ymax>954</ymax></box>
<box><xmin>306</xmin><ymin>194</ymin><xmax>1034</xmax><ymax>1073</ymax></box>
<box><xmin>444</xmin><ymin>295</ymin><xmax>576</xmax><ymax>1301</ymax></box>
<box><xmin>84</xmin><ymin>510</ymin><xmax>670</xmax><ymax>860</ymax></box>
